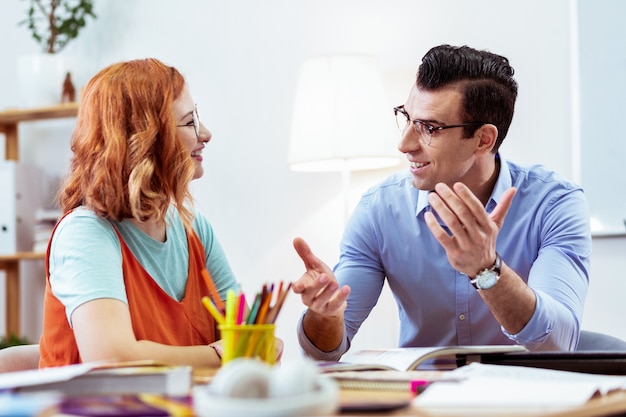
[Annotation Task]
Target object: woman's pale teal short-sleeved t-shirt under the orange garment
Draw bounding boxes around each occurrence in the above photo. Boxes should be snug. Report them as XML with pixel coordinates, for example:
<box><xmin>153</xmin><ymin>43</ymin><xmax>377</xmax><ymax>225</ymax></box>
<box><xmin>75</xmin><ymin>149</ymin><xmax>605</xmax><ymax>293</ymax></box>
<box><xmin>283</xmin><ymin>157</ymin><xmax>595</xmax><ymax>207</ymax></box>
<box><xmin>49</xmin><ymin>206</ymin><xmax>239</xmax><ymax>324</ymax></box>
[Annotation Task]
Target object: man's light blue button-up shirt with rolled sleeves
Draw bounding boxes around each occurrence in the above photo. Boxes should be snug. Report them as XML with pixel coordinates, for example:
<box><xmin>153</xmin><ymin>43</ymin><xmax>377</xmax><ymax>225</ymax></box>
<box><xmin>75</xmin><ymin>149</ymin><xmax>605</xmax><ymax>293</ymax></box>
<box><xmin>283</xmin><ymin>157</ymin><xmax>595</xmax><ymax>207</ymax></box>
<box><xmin>298</xmin><ymin>156</ymin><xmax>591</xmax><ymax>360</ymax></box>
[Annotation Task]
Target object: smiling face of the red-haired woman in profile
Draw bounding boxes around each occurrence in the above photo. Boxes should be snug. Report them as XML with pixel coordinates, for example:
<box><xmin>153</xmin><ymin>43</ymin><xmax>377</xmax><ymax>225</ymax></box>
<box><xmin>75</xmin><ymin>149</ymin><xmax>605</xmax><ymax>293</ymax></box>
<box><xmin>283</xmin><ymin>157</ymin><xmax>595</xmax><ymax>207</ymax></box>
<box><xmin>174</xmin><ymin>87</ymin><xmax>211</xmax><ymax>179</ymax></box>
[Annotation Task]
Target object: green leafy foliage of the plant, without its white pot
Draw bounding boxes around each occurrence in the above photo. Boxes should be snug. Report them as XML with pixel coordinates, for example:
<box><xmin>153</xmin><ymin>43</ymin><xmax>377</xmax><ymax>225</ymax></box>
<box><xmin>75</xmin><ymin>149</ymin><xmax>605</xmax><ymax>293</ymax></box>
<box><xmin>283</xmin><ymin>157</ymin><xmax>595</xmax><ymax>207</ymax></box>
<box><xmin>19</xmin><ymin>0</ymin><xmax>96</xmax><ymax>54</ymax></box>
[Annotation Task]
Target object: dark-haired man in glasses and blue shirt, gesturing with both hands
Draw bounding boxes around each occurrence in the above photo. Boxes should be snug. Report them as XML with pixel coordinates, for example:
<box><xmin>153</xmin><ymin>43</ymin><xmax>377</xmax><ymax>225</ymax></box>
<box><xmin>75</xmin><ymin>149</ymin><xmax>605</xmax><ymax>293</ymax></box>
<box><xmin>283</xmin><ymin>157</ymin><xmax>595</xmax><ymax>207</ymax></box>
<box><xmin>293</xmin><ymin>45</ymin><xmax>591</xmax><ymax>360</ymax></box>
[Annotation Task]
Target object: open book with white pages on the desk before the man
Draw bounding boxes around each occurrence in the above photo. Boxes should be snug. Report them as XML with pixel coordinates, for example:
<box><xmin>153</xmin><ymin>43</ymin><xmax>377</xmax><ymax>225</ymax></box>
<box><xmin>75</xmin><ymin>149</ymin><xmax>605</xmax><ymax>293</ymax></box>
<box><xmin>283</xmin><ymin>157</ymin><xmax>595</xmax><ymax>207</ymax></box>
<box><xmin>318</xmin><ymin>345</ymin><xmax>528</xmax><ymax>372</ymax></box>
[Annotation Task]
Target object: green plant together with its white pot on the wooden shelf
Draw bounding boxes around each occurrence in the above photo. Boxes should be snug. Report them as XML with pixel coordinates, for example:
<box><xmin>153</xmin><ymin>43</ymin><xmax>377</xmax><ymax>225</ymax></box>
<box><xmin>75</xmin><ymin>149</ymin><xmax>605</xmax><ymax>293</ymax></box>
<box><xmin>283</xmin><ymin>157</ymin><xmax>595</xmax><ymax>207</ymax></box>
<box><xmin>17</xmin><ymin>0</ymin><xmax>96</xmax><ymax>107</ymax></box>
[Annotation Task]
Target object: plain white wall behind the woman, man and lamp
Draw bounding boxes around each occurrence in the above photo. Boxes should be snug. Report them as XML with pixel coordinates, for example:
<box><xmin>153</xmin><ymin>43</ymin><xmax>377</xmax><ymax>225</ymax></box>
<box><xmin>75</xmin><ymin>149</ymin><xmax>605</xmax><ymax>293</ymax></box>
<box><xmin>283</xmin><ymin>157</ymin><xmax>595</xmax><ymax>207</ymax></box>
<box><xmin>0</xmin><ymin>0</ymin><xmax>626</xmax><ymax>358</ymax></box>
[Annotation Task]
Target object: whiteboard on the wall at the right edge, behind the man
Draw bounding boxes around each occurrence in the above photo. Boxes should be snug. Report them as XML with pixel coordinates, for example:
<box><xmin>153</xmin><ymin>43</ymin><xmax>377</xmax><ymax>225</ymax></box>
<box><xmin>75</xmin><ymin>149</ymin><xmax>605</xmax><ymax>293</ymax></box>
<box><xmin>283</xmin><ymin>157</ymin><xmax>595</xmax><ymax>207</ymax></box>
<box><xmin>578</xmin><ymin>0</ymin><xmax>626</xmax><ymax>233</ymax></box>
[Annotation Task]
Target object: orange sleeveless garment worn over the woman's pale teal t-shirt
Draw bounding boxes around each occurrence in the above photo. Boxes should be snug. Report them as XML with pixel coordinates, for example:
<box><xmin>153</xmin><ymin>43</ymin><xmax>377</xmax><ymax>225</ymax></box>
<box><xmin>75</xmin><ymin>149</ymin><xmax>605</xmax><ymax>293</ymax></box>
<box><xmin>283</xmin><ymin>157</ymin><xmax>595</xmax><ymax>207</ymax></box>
<box><xmin>39</xmin><ymin>216</ymin><xmax>217</xmax><ymax>368</ymax></box>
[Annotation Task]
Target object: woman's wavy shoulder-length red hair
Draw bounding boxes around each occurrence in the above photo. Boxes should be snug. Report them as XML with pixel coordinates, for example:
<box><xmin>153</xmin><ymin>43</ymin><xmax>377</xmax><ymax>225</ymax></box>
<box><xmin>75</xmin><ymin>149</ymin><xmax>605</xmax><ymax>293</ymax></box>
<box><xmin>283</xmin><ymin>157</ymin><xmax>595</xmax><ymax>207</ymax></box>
<box><xmin>59</xmin><ymin>59</ymin><xmax>195</xmax><ymax>226</ymax></box>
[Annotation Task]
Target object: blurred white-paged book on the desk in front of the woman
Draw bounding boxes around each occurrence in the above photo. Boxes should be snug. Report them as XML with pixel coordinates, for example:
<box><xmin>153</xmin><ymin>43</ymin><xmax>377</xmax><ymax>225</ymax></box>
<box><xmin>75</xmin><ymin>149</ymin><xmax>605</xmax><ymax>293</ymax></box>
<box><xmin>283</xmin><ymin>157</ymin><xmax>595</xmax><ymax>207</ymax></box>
<box><xmin>0</xmin><ymin>361</ymin><xmax>192</xmax><ymax>396</ymax></box>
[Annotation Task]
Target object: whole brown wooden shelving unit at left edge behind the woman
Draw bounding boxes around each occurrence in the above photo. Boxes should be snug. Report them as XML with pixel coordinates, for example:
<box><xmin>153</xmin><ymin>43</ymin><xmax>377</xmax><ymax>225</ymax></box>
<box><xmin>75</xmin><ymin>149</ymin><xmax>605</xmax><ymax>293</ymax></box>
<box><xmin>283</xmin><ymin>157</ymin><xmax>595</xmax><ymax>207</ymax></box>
<box><xmin>0</xmin><ymin>103</ymin><xmax>78</xmax><ymax>336</ymax></box>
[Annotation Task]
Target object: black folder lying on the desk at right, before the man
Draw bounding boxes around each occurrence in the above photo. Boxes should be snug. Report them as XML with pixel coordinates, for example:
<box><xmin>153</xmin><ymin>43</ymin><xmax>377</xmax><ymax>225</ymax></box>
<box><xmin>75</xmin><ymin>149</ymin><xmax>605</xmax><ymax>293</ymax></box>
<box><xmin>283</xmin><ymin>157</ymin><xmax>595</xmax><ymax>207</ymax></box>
<box><xmin>456</xmin><ymin>351</ymin><xmax>626</xmax><ymax>375</ymax></box>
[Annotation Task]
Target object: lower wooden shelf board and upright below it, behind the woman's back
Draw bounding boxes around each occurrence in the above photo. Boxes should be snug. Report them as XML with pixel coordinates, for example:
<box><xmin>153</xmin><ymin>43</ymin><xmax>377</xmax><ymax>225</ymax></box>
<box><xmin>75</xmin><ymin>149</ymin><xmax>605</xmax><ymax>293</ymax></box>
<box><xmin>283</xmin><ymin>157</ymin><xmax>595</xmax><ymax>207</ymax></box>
<box><xmin>0</xmin><ymin>252</ymin><xmax>46</xmax><ymax>337</ymax></box>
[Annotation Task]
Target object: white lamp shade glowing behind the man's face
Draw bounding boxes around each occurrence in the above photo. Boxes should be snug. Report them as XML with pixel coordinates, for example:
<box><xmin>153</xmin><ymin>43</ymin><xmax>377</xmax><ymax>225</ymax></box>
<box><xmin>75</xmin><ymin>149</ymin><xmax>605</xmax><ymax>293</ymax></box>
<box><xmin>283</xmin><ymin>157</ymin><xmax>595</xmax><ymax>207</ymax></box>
<box><xmin>288</xmin><ymin>56</ymin><xmax>400</xmax><ymax>172</ymax></box>
